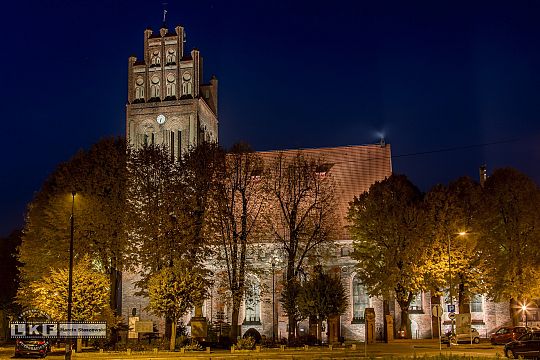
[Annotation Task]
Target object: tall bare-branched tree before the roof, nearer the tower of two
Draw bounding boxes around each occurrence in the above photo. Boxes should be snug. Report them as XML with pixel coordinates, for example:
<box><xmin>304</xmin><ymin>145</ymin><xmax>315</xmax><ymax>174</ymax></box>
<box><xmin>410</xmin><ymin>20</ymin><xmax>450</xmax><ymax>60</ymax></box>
<box><xmin>214</xmin><ymin>143</ymin><xmax>265</xmax><ymax>339</ymax></box>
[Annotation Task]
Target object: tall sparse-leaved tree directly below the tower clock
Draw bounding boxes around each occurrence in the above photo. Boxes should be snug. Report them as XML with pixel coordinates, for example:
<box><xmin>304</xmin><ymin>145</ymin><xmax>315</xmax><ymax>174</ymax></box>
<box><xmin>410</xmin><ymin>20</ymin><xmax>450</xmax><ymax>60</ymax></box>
<box><xmin>126</xmin><ymin>145</ymin><xmax>188</xmax><ymax>295</ymax></box>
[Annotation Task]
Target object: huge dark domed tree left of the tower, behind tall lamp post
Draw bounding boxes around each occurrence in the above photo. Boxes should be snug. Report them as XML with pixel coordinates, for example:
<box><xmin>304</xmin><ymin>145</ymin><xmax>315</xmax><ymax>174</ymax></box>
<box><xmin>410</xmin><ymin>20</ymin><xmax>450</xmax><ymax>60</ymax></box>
<box><xmin>19</xmin><ymin>138</ymin><xmax>127</xmax><ymax>311</ymax></box>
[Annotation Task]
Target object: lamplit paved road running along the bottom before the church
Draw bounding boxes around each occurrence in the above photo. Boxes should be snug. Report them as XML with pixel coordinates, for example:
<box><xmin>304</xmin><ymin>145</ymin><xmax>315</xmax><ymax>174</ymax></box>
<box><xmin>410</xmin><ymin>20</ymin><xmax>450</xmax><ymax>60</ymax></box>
<box><xmin>0</xmin><ymin>340</ymin><xmax>503</xmax><ymax>360</ymax></box>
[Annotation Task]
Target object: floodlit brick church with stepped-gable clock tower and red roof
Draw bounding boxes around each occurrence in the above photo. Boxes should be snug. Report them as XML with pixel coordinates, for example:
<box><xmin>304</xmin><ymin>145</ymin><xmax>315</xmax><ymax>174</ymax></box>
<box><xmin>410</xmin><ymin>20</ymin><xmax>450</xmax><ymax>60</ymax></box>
<box><xmin>122</xmin><ymin>22</ymin><xmax>528</xmax><ymax>340</ymax></box>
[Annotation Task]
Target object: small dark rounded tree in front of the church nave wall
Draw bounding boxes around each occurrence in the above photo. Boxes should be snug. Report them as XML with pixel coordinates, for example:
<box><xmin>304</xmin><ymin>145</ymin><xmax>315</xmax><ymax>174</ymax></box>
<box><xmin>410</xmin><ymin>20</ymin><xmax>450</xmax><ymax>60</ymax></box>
<box><xmin>298</xmin><ymin>266</ymin><xmax>348</xmax><ymax>341</ymax></box>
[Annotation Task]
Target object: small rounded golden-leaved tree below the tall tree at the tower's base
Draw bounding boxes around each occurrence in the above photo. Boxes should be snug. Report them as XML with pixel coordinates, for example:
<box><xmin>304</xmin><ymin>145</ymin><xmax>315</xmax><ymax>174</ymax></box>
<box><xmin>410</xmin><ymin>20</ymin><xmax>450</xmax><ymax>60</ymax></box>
<box><xmin>148</xmin><ymin>263</ymin><xmax>210</xmax><ymax>351</ymax></box>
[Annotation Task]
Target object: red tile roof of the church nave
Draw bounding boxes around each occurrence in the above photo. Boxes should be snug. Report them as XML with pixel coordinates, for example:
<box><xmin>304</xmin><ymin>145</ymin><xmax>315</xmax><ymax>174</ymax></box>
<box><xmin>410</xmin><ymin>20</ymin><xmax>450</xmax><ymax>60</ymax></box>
<box><xmin>258</xmin><ymin>144</ymin><xmax>392</xmax><ymax>240</ymax></box>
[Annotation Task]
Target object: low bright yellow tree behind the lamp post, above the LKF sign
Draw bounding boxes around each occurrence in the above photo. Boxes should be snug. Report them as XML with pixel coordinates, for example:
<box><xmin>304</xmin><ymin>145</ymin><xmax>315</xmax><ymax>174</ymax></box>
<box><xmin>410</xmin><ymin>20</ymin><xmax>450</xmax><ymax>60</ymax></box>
<box><xmin>23</xmin><ymin>258</ymin><xmax>111</xmax><ymax>321</ymax></box>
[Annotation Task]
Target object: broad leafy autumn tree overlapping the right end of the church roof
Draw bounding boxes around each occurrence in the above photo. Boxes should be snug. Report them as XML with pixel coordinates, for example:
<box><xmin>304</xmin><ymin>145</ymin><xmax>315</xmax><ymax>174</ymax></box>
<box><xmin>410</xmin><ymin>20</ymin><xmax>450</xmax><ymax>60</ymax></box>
<box><xmin>348</xmin><ymin>175</ymin><xmax>427</xmax><ymax>337</ymax></box>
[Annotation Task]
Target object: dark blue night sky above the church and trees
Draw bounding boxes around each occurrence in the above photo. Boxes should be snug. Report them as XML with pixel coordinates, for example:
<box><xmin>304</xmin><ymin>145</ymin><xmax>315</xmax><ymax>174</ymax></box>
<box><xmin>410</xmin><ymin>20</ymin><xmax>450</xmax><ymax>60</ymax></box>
<box><xmin>0</xmin><ymin>0</ymin><xmax>540</xmax><ymax>235</ymax></box>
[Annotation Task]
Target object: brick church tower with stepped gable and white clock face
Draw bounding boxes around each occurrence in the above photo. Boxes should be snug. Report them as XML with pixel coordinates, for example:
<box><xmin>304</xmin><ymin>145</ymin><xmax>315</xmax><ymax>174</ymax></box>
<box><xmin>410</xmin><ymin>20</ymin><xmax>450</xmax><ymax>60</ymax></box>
<box><xmin>126</xmin><ymin>26</ymin><xmax>218</xmax><ymax>158</ymax></box>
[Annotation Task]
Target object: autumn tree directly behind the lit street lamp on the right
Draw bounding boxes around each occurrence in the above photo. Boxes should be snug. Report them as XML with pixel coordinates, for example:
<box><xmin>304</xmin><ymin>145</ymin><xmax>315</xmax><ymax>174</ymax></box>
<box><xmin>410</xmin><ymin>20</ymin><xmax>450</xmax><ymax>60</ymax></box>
<box><xmin>425</xmin><ymin>177</ymin><xmax>485</xmax><ymax>314</ymax></box>
